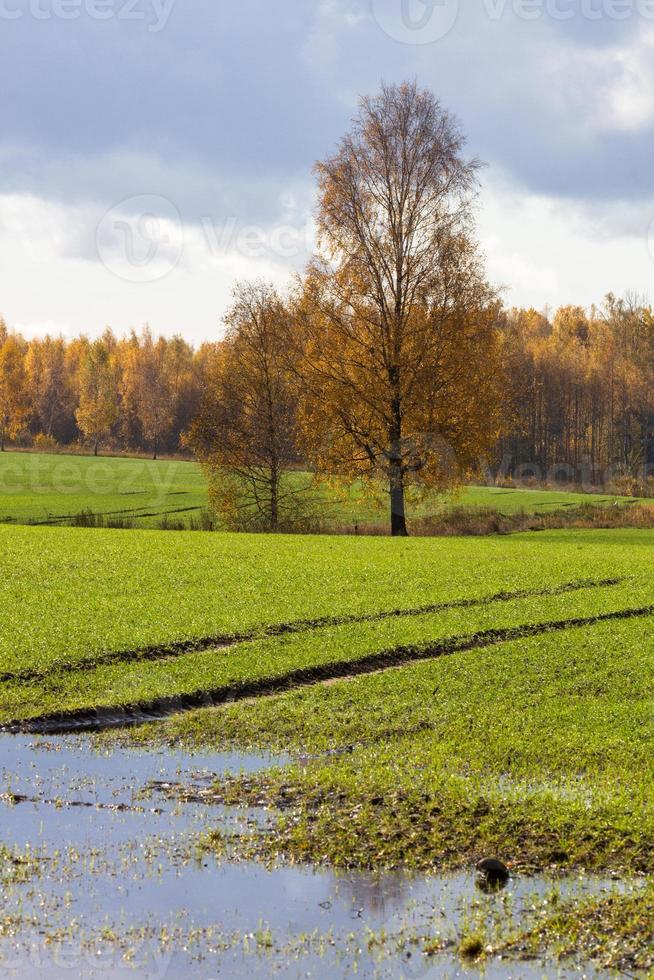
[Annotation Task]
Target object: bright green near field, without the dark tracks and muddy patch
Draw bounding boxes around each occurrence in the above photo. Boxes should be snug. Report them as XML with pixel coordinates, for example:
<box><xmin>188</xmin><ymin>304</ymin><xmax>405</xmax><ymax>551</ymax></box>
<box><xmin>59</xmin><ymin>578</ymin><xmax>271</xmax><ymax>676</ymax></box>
<box><xmin>0</xmin><ymin>527</ymin><xmax>654</xmax><ymax>840</ymax></box>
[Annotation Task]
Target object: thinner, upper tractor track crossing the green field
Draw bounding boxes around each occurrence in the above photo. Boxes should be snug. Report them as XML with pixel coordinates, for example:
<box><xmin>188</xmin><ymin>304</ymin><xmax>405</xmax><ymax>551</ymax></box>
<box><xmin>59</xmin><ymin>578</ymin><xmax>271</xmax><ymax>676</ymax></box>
<box><xmin>0</xmin><ymin>578</ymin><xmax>625</xmax><ymax>684</ymax></box>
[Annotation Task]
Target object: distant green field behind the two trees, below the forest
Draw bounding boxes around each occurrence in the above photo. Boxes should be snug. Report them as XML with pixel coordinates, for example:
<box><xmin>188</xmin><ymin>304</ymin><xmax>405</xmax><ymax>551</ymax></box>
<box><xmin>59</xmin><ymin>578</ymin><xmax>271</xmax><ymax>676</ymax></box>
<box><xmin>0</xmin><ymin>453</ymin><xmax>635</xmax><ymax>528</ymax></box>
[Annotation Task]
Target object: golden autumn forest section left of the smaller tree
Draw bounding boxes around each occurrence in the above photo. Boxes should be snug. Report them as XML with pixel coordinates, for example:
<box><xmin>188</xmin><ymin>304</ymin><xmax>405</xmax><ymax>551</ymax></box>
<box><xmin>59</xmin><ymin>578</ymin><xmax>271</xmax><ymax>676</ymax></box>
<box><xmin>0</xmin><ymin>319</ymin><xmax>216</xmax><ymax>458</ymax></box>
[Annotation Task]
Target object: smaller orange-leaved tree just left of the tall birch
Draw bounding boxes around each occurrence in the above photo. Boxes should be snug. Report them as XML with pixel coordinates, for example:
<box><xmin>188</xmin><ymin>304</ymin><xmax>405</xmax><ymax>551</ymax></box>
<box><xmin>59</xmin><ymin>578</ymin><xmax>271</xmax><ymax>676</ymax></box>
<box><xmin>189</xmin><ymin>282</ymin><xmax>303</xmax><ymax>531</ymax></box>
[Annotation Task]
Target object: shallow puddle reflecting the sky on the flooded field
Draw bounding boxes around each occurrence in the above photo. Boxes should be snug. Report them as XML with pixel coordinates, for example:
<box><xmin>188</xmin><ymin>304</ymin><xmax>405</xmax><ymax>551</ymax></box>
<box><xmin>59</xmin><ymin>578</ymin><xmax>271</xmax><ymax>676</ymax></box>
<box><xmin>0</xmin><ymin>736</ymin><xmax>644</xmax><ymax>980</ymax></box>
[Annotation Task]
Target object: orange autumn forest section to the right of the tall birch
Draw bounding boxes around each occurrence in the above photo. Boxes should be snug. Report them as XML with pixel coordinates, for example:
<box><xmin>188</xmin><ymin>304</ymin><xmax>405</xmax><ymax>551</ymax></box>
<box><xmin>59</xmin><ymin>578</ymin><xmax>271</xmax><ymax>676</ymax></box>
<box><xmin>498</xmin><ymin>294</ymin><xmax>654</xmax><ymax>488</ymax></box>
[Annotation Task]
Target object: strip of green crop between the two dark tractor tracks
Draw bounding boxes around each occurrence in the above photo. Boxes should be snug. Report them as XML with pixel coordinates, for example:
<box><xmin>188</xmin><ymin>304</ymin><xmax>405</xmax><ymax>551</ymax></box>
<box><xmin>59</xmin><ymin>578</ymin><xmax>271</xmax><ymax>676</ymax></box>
<box><xmin>0</xmin><ymin>582</ymin><xmax>654</xmax><ymax>722</ymax></box>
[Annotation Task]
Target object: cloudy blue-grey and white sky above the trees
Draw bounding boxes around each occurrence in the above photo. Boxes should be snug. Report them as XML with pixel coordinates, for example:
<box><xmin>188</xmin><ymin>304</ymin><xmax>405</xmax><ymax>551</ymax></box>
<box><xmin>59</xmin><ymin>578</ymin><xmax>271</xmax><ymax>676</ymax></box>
<box><xmin>0</xmin><ymin>0</ymin><xmax>654</xmax><ymax>342</ymax></box>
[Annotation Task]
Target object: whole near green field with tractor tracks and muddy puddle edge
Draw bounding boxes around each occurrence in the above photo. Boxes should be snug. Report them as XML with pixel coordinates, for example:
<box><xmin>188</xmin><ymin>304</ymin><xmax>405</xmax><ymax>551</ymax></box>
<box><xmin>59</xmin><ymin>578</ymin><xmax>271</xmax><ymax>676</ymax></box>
<box><xmin>0</xmin><ymin>476</ymin><xmax>654</xmax><ymax>965</ymax></box>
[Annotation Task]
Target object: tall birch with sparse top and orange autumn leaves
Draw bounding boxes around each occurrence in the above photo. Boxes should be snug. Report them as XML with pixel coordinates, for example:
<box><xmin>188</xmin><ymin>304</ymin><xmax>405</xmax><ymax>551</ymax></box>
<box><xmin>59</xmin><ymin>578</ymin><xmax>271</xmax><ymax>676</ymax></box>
<box><xmin>298</xmin><ymin>84</ymin><xmax>508</xmax><ymax>535</ymax></box>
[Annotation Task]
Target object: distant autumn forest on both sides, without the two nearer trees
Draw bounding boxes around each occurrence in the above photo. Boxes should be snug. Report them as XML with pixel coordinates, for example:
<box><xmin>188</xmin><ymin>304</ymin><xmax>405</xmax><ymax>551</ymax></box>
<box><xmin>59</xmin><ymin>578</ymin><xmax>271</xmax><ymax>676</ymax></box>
<box><xmin>0</xmin><ymin>295</ymin><xmax>654</xmax><ymax>485</ymax></box>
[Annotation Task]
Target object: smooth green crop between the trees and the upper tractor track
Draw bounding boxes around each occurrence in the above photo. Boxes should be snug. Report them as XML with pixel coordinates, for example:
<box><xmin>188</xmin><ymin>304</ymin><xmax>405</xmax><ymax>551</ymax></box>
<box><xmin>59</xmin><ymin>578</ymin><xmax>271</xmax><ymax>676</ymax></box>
<box><xmin>0</xmin><ymin>526</ymin><xmax>654</xmax><ymax>693</ymax></box>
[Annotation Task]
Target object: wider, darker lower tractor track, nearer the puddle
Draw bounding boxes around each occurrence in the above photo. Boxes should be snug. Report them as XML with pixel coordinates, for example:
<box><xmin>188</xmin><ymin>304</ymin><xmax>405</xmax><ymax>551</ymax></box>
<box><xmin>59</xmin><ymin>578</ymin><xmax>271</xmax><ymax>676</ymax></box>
<box><xmin>0</xmin><ymin>588</ymin><xmax>654</xmax><ymax>735</ymax></box>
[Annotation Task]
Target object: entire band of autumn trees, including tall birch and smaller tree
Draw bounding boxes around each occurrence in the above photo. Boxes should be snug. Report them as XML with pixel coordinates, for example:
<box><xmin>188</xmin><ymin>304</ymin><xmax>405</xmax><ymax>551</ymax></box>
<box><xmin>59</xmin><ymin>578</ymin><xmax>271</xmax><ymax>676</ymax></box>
<box><xmin>0</xmin><ymin>83</ymin><xmax>654</xmax><ymax>535</ymax></box>
